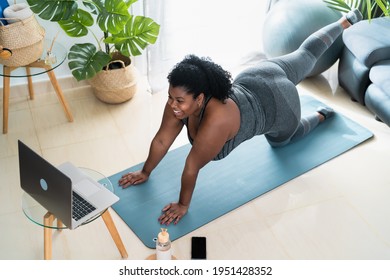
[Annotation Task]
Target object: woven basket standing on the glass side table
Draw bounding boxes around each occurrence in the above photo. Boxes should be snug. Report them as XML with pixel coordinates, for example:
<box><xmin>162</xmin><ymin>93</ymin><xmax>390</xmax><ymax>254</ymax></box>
<box><xmin>0</xmin><ymin>15</ymin><xmax>45</xmax><ymax>67</ymax></box>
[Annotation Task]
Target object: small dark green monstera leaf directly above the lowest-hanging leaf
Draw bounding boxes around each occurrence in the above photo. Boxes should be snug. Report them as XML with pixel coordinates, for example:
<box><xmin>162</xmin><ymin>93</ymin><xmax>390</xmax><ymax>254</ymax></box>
<box><xmin>58</xmin><ymin>9</ymin><xmax>94</xmax><ymax>37</ymax></box>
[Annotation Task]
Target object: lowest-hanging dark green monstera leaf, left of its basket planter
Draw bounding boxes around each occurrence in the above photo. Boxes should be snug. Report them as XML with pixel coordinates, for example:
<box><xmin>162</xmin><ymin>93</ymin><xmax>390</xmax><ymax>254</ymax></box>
<box><xmin>68</xmin><ymin>43</ymin><xmax>111</xmax><ymax>81</ymax></box>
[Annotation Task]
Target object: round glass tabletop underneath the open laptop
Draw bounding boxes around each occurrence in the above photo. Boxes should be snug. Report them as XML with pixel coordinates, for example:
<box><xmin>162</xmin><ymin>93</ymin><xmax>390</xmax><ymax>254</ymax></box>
<box><xmin>22</xmin><ymin>167</ymin><xmax>114</xmax><ymax>229</ymax></box>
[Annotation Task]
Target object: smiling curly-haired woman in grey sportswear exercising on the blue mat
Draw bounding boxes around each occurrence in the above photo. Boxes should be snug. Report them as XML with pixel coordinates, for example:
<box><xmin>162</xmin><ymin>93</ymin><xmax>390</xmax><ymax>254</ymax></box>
<box><xmin>119</xmin><ymin>10</ymin><xmax>362</xmax><ymax>225</ymax></box>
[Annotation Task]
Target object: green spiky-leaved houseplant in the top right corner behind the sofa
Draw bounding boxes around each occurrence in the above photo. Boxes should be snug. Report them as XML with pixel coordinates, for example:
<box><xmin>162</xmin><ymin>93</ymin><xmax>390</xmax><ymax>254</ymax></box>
<box><xmin>323</xmin><ymin>0</ymin><xmax>390</xmax><ymax>19</ymax></box>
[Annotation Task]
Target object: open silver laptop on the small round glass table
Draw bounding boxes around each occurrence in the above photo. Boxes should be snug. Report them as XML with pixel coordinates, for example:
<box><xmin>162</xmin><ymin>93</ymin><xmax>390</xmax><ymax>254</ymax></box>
<box><xmin>18</xmin><ymin>140</ymin><xmax>119</xmax><ymax>229</ymax></box>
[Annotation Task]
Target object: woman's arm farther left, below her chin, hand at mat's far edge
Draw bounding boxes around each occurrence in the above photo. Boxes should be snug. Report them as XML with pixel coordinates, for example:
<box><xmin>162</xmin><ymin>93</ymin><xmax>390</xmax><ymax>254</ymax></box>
<box><xmin>119</xmin><ymin>103</ymin><xmax>183</xmax><ymax>188</ymax></box>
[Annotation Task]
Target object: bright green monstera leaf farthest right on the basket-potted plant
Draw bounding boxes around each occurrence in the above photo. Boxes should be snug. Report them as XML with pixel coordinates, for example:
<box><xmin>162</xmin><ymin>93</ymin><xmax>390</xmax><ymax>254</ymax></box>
<box><xmin>104</xmin><ymin>16</ymin><xmax>160</xmax><ymax>56</ymax></box>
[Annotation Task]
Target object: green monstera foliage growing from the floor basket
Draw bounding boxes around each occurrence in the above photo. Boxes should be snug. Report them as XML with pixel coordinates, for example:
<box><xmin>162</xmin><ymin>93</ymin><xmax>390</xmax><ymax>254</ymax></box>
<box><xmin>27</xmin><ymin>0</ymin><xmax>160</xmax><ymax>81</ymax></box>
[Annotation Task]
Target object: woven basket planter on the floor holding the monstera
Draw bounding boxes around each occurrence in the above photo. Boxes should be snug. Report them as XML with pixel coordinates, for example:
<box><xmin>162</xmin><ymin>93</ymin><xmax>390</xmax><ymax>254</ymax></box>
<box><xmin>88</xmin><ymin>58</ymin><xmax>137</xmax><ymax>104</ymax></box>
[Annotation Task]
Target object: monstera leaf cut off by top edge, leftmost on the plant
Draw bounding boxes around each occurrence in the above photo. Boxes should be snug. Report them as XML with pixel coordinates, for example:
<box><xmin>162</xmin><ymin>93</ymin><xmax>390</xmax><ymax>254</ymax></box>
<box><xmin>27</xmin><ymin>0</ymin><xmax>78</xmax><ymax>21</ymax></box>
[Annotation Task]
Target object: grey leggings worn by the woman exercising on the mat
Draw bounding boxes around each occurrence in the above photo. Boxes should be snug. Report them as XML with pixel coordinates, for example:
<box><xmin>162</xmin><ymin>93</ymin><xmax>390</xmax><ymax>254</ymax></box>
<box><xmin>259</xmin><ymin>22</ymin><xmax>344</xmax><ymax>147</ymax></box>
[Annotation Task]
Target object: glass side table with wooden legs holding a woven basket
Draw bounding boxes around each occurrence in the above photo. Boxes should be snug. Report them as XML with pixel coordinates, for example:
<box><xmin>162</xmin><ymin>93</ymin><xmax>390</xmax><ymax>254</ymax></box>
<box><xmin>0</xmin><ymin>41</ymin><xmax>73</xmax><ymax>134</ymax></box>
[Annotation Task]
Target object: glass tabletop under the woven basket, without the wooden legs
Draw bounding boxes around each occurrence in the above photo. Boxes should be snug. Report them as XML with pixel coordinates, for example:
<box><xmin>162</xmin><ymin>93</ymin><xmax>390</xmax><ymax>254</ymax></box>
<box><xmin>0</xmin><ymin>40</ymin><xmax>67</xmax><ymax>78</ymax></box>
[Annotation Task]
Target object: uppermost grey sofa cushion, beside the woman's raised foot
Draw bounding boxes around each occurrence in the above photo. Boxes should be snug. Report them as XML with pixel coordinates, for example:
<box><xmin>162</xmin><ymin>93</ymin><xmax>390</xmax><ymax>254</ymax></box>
<box><xmin>343</xmin><ymin>17</ymin><xmax>390</xmax><ymax>68</ymax></box>
